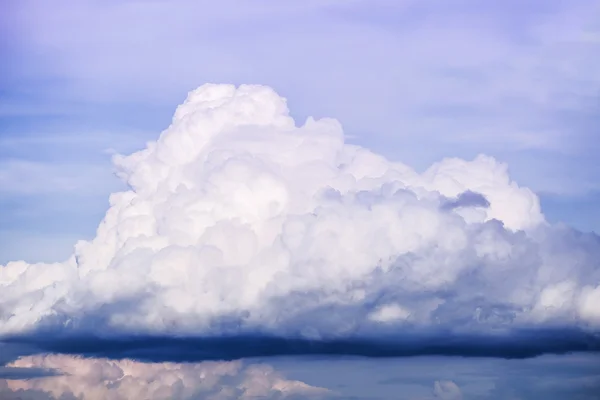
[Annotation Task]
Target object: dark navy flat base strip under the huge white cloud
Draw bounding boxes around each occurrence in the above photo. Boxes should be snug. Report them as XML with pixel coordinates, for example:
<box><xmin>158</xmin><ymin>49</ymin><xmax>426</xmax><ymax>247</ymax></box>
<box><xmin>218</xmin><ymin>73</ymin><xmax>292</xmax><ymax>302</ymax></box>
<box><xmin>2</xmin><ymin>330</ymin><xmax>600</xmax><ymax>362</ymax></box>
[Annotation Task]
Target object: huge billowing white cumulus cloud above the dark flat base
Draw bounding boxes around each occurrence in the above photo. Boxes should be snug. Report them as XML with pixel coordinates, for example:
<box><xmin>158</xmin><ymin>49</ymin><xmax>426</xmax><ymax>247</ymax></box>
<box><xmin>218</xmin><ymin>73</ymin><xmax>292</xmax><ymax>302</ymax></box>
<box><xmin>0</xmin><ymin>84</ymin><xmax>600</xmax><ymax>344</ymax></box>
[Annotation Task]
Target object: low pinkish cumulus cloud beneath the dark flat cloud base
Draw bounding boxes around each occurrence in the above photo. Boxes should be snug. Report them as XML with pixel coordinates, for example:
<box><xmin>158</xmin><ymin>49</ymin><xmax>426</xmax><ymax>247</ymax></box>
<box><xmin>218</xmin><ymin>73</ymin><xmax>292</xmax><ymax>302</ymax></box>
<box><xmin>0</xmin><ymin>355</ymin><xmax>331</xmax><ymax>400</ymax></box>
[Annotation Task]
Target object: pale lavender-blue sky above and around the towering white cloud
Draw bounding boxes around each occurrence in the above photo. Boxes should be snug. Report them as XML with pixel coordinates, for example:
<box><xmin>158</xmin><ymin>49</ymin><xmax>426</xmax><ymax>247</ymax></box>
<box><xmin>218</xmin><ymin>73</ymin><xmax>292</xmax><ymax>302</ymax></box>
<box><xmin>0</xmin><ymin>0</ymin><xmax>600</xmax><ymax>263</ymax></box>
